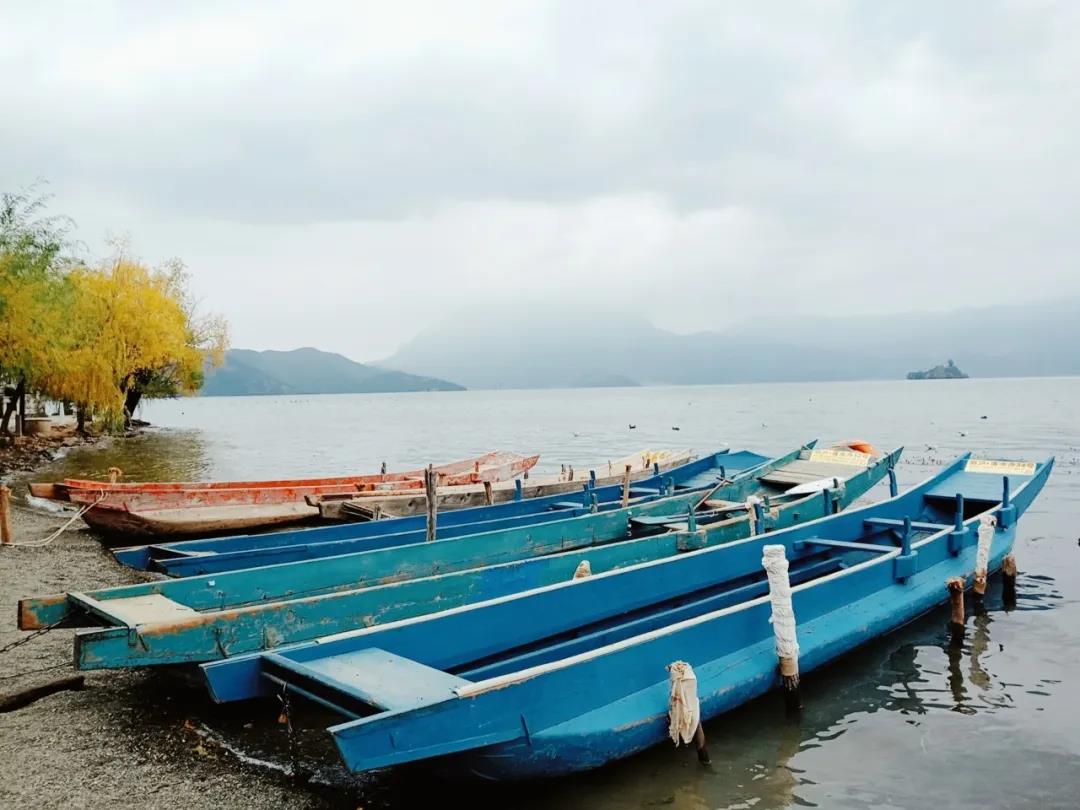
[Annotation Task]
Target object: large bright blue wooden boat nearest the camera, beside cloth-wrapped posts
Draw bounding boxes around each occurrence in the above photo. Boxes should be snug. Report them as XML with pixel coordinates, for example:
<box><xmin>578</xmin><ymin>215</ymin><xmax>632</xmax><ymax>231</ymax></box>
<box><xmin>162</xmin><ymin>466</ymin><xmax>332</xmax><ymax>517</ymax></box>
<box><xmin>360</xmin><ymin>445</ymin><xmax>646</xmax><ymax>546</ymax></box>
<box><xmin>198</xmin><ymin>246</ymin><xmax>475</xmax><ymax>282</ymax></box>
<box><xmin>203</xmin><ymin>457</ymin><xmax>1053</xmax><ymax>780</ymax></box>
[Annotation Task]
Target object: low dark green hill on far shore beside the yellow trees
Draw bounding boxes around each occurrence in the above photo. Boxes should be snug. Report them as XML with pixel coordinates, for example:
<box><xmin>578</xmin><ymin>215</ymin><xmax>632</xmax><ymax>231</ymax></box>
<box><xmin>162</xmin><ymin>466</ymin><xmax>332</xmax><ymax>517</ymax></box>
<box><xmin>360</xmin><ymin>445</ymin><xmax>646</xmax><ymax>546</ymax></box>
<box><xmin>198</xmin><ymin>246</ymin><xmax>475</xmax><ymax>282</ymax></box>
<box><xmin>202</xmin><ymin>348</ymin><xmax>464</xmax><ymax>396</ymax></box>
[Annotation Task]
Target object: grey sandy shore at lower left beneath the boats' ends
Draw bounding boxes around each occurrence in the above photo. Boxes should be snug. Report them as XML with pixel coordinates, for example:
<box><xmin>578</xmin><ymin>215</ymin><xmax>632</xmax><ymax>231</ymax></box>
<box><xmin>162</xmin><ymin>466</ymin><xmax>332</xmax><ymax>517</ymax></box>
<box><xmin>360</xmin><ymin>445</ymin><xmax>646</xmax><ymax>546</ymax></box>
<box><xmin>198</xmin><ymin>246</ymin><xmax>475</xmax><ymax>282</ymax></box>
<box><xmin>0</xmin><ymin>504</ymin><xmax>397</xmax><ymax>808</ymax></box>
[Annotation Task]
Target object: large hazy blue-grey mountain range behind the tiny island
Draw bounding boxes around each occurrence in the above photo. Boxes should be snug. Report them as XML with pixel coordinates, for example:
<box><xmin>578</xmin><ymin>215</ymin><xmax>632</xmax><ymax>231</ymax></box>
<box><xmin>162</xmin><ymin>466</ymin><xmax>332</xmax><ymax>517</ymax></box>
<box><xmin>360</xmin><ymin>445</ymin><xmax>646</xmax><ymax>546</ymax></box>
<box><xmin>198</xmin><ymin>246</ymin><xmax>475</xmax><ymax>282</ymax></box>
<box><xmin>378</xmin><ymin>300</ymin><xmax>1080</xmax><ymax>389</ymax></box>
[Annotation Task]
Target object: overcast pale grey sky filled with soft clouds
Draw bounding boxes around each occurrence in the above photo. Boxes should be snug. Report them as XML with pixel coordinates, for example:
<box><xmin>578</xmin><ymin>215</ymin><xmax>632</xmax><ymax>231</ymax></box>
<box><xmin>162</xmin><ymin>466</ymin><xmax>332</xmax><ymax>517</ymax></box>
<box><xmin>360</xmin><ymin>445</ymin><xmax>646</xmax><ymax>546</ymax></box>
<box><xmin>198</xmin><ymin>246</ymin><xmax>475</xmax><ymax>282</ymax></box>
<box><xmin>0</xmin><ymin>0</ymin><xmax>1080</xmax><ymax>360</ymax></box>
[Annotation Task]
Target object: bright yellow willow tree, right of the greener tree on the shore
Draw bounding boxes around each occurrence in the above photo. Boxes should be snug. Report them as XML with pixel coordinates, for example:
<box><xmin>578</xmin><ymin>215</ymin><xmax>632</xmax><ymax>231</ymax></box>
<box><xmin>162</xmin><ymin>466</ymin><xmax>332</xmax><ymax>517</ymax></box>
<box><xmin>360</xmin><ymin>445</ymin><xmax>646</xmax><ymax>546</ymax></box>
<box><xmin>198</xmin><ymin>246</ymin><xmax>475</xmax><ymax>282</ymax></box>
<box><xmin>40</xmin><ymin>258</ymin><xmax>226</xmax><ymax>428</ymax></box>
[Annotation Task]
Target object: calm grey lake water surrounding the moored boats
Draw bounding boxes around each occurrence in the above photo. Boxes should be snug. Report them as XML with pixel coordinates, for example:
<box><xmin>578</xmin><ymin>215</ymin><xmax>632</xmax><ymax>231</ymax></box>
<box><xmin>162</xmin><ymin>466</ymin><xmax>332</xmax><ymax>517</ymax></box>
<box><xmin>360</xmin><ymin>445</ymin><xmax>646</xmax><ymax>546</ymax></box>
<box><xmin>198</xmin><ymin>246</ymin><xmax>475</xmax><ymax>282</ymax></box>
<box><xmin>23</xmin><ymin>378</ymin><xmax>1080</xmax><ymax>808</ymax></box>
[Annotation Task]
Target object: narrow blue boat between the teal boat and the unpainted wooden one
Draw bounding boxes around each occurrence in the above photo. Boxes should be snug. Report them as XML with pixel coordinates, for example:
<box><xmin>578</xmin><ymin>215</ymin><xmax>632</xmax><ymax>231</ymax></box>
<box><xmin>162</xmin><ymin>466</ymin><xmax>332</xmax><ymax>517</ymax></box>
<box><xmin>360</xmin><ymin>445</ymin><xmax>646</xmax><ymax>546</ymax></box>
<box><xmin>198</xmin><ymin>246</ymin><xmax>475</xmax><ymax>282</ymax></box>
<box><xmin>112</xmin><ymin>443</ymin><xmax>751</xmax><ymax>577</ymax></box>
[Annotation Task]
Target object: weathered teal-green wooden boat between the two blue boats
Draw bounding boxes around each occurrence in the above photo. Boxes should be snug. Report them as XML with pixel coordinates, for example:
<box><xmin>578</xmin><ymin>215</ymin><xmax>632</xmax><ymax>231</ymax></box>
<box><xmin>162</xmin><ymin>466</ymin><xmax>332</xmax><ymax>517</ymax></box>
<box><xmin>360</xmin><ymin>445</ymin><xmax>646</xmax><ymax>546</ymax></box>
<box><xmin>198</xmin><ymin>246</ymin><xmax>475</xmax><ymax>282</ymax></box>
<box><xmin>18</xmin><ymin>449</ymin><xmax>900</xmax><ymax>670</ymax></box>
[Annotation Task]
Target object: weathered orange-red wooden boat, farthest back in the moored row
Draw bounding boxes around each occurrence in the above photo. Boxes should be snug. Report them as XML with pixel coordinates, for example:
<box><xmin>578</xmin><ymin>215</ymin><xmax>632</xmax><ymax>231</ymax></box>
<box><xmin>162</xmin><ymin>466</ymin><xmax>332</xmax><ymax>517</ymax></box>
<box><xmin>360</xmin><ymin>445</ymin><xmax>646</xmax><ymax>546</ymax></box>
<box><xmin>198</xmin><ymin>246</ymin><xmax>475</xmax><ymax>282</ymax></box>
<box><xmin>30</xmin><ymin>453</ymin><xmax>540</xmax><ymax>535</ymax></box>
